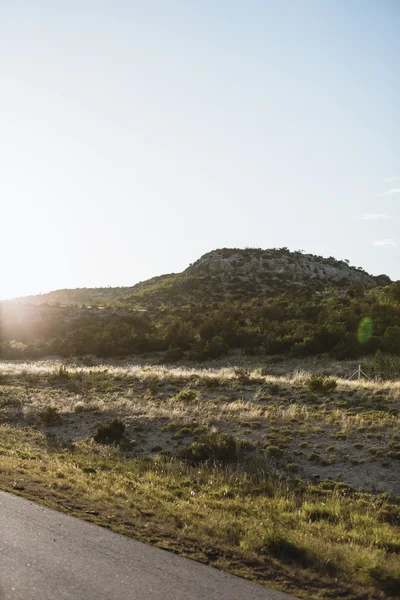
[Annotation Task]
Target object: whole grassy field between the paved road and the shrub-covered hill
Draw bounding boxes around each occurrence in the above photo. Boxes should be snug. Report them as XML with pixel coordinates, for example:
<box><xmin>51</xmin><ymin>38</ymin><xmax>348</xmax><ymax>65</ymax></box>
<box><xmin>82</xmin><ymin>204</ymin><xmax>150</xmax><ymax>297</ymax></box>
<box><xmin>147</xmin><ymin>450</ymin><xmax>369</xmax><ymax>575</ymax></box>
<box><xmin>0</xmin><ymin>362</ymin><xmax>400</xmax><ymax>599</ymax></box>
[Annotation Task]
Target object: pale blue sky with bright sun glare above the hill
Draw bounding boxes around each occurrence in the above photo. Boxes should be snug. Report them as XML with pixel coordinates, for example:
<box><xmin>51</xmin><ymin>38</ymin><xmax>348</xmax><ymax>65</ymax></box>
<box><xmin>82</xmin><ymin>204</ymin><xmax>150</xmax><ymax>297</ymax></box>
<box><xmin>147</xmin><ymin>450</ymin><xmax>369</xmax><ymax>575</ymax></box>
<box><xmin>0</xmin><ymin>0</ymin><xmax>400</xmax><ymax>299</ymax></box>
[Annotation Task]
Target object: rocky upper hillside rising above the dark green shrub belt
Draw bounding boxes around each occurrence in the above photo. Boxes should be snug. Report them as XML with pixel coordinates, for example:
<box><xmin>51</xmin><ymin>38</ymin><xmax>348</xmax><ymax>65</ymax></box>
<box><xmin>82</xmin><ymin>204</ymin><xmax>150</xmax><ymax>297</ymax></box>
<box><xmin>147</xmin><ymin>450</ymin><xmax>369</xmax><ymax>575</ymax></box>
<box><xmin>9</xmin><ymin>248</ymin><xmax>390</xmax><ymax>309</ymax></box>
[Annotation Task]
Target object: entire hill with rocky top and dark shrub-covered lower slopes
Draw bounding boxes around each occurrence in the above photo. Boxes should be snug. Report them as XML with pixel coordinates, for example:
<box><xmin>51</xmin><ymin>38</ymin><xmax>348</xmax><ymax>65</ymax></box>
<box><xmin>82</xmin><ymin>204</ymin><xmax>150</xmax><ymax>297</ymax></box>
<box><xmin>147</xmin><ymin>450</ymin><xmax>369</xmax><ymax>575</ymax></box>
<box><xmin>0</xmin><ymin>248</ymin><xmax>400</xmax><ymax>364</ymax></box>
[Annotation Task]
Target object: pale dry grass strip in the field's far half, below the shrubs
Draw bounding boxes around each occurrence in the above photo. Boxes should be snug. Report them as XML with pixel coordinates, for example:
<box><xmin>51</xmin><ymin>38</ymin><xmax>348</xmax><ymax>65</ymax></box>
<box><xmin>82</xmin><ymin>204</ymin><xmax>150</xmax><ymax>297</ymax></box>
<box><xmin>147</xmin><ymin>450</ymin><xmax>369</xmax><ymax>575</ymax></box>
<box><xmin>0</xmin><ymin>362</ymin><xmax>400</xmax><ymax>494</ymax></box>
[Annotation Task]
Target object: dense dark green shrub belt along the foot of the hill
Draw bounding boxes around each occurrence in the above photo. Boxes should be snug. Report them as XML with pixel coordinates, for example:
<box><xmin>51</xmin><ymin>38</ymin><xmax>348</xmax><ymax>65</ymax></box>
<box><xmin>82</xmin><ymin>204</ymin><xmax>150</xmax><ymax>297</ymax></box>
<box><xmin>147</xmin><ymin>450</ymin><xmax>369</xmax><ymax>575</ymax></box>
<box><xmin>0</xmin><ymin>284</ymin><xmax>400</xmax><ymax>364</ymax></box>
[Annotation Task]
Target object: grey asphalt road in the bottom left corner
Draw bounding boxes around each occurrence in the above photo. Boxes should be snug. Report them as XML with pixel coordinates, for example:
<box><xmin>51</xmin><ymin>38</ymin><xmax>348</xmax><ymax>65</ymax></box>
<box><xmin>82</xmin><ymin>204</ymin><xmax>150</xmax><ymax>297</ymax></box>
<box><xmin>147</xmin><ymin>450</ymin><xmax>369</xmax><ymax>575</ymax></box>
<box><xmin>0</xmin><ymin>492</ymin><xmax>294</xmax><ymax>600</ymax></box>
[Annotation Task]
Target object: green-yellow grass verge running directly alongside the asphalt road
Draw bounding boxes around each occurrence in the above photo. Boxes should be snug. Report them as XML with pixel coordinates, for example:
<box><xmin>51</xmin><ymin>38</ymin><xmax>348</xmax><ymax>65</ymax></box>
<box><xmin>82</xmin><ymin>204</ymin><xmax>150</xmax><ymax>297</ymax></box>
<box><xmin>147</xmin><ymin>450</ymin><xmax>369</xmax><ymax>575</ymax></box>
<box><xmin>0</xmin><ymin>426</ymin><xmax>400</xmax><ymax>600</ymax></box>
